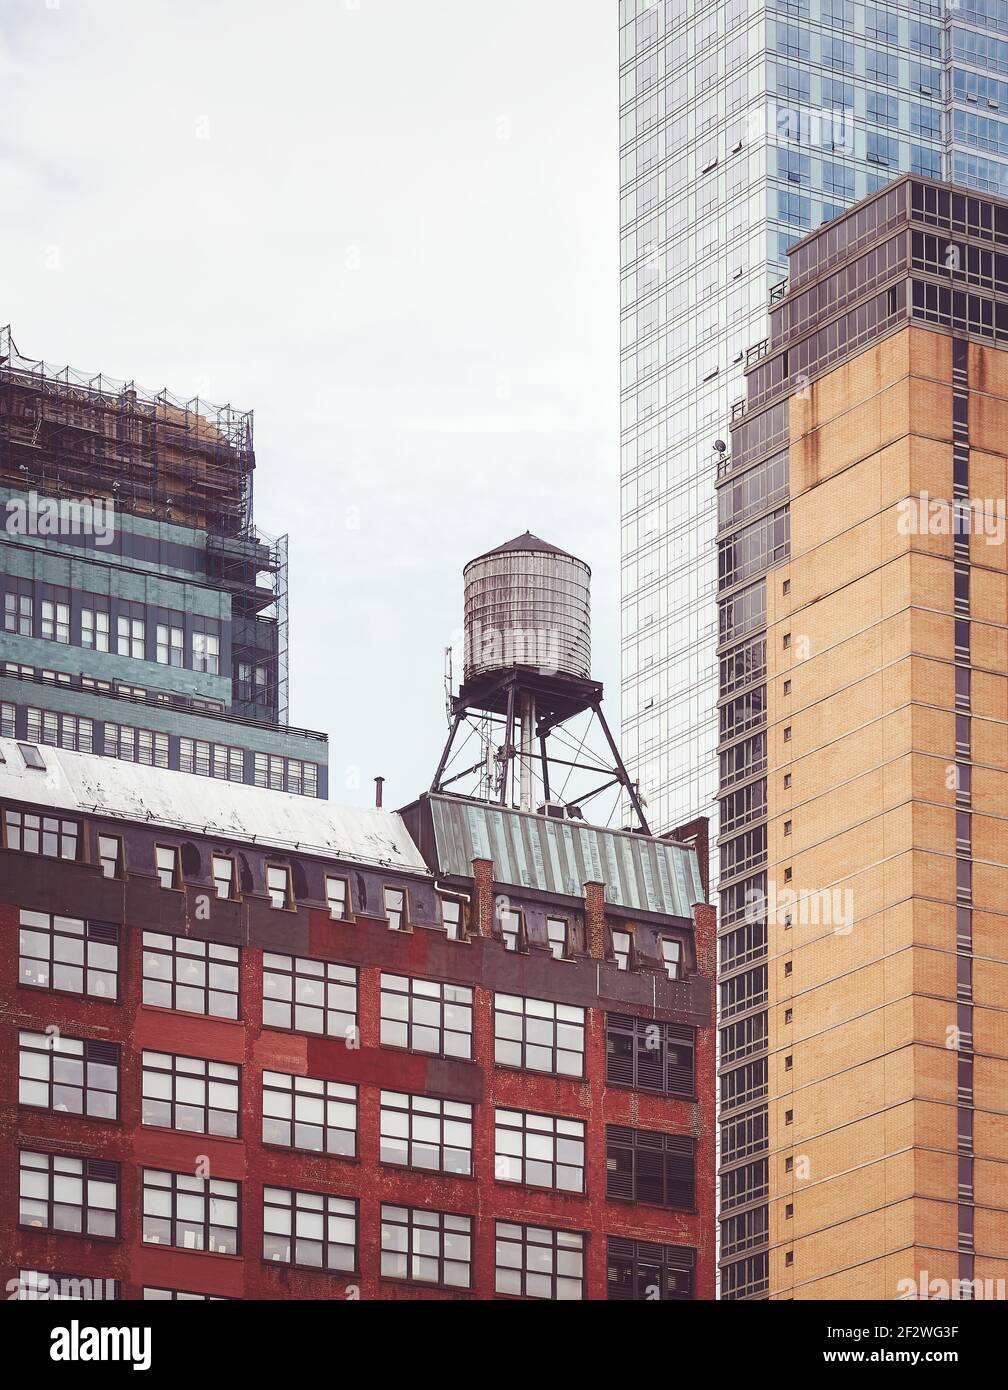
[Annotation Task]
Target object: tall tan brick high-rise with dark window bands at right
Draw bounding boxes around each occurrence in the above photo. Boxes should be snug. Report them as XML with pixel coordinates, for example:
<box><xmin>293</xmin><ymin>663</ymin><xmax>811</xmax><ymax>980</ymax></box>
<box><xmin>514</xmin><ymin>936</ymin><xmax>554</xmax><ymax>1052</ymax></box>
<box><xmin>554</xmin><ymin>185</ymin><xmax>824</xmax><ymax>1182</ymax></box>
<box><xmin>719</xmin><ymin>178</ymin><xmax>1008</xmax><ymax>1298</ymax></box>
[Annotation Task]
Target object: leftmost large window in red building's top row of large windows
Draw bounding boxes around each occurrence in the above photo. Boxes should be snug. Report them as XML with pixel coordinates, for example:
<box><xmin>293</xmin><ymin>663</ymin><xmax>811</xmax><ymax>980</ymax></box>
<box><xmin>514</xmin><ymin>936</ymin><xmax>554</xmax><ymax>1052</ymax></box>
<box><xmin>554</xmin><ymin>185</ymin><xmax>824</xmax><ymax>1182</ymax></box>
<box><xmin>18</xmin><ymin>910</ymin><xmax>120</xmax><ymax>1001</ymax></box>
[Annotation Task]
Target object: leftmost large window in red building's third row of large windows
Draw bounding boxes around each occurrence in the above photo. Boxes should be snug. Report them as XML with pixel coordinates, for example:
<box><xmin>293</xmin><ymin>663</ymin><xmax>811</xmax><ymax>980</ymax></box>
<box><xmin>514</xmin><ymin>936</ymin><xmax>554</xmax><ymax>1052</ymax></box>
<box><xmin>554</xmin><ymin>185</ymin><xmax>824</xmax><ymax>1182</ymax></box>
<box><xmin>18</xmin><ymin>1150</ymin><xmax>120</xmax><ymax>1237</ymax></box>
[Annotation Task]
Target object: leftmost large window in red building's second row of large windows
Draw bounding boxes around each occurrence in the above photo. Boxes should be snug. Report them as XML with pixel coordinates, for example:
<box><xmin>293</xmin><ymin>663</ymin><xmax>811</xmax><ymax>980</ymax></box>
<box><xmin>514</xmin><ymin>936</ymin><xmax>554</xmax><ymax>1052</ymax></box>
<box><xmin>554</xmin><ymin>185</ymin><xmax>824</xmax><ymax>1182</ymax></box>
<box><xmin>18</xmin><ymin>1033</ymin><xmax>120</xmax><ymax>1120</ymax></box>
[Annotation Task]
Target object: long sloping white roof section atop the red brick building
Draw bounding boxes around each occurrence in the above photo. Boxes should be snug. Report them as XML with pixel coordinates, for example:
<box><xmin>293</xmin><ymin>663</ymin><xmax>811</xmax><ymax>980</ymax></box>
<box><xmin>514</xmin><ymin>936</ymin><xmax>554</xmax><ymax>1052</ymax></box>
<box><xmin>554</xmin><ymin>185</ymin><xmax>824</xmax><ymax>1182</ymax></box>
<box><xmin>0</xmin><ymin>738</ymin><xmax>430</xmax><ymax>877</ymax></box>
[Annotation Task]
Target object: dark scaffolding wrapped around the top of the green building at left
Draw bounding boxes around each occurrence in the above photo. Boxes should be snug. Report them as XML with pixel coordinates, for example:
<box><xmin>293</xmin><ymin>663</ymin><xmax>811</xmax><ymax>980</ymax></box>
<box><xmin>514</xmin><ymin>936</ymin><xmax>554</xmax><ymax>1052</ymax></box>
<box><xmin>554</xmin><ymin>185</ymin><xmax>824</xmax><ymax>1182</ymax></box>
<box><xmin>0</xmin><ymin>325</ymin><xmax>256</xmax><ymax>537</ymax></box>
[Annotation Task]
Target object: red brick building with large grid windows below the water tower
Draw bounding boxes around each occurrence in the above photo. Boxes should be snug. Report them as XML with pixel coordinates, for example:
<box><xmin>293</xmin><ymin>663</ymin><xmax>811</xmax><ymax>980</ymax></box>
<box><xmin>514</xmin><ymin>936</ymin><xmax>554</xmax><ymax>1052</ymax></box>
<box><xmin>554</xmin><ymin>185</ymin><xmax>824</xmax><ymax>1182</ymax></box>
<box><xmin>0</xmin><ymin>739</ymin><xmax>715</xmax><ymax>1300</ymax></box>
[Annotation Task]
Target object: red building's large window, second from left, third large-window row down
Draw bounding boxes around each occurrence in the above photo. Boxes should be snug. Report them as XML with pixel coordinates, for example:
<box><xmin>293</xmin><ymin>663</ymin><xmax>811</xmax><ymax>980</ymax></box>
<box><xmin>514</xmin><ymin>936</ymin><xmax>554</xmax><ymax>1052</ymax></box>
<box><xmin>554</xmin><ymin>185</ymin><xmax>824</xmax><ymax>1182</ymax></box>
<box><xmin>143</xmin><ymin>1168</ymin><xmax>239</xmax><ymax>1255</ymax></box>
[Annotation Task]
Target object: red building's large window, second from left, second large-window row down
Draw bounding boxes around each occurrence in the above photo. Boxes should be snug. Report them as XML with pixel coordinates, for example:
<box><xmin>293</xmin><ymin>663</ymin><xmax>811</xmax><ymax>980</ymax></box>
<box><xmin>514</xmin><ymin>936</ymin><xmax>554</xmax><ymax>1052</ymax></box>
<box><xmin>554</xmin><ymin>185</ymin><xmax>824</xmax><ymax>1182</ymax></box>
<box><xmin>142</xmin><ymin>1051</ymin><xmax>238</xmax><ymax>1138</ymax></box>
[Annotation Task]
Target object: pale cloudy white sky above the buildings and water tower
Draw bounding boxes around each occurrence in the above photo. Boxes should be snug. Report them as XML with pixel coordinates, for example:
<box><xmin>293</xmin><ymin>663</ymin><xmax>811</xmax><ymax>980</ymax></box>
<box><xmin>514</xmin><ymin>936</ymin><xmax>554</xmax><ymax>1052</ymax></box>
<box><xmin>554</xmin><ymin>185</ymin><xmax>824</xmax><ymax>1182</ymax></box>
<box><xmin>0</xmin><ymin>0</ymin><xmax>619</xmax><ymax>805</ymax></box>
